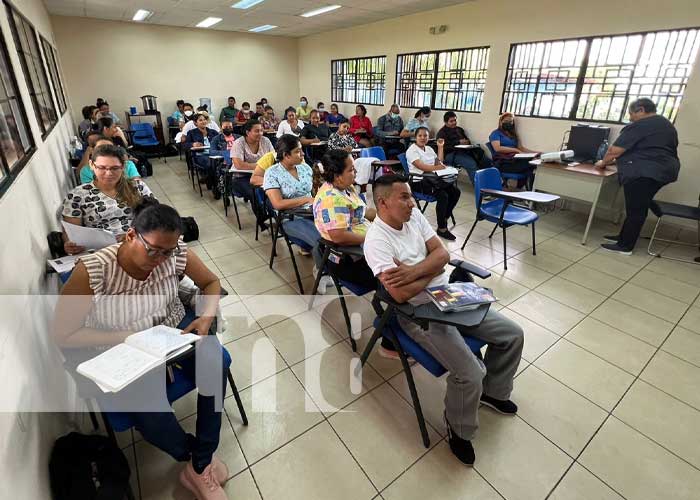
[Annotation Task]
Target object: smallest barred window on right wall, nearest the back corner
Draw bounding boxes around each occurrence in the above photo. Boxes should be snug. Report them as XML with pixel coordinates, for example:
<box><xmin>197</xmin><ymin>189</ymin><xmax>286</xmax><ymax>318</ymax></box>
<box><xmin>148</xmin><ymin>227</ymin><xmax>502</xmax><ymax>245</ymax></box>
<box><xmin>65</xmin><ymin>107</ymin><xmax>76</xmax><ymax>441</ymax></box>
<box><xmin>331</xmin><ymin>56</ymin><xmax>386</xmax><ymax>106</ymax></box>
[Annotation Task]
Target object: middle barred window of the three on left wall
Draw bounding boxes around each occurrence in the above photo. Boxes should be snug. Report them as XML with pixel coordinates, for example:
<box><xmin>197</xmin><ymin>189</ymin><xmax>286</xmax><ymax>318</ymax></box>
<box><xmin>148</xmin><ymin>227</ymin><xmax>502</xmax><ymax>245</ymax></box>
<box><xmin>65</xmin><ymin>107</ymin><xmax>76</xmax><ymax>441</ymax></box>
<box><xmin>6</xmin><ymin>3</ymin><xmax>58</xmax><ymax>138</ymax></box>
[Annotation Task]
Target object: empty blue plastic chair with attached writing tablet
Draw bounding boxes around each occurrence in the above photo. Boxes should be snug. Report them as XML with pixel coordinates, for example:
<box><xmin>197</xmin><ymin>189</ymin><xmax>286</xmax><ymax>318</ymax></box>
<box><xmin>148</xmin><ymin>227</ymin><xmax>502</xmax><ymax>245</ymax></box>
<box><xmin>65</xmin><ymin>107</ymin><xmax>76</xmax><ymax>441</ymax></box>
<box><xmin>462</xmin><ymin>167</ymin><xmax>539</xmax><ymax>269</ymax></box>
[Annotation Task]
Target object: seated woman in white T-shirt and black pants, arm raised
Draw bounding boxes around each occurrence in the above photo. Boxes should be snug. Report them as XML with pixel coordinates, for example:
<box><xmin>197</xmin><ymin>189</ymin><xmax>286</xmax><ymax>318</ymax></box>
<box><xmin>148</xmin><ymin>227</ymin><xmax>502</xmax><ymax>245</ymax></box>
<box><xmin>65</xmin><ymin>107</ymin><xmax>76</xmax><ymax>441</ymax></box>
<box><xmin>406</xmin><ymin>127</ymin><xmax>461</xmax><ymax>241</ymax></box>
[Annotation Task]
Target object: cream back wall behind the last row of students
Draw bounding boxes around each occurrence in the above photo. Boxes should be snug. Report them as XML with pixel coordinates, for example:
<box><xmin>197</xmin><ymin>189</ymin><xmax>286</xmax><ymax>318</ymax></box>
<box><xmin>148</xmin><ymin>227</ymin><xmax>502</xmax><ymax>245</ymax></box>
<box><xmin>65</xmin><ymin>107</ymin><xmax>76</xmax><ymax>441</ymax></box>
<box><xmin>51</xmin><ymin>16</ymin><xmax>299</xmax><ymax>125</ymax></box>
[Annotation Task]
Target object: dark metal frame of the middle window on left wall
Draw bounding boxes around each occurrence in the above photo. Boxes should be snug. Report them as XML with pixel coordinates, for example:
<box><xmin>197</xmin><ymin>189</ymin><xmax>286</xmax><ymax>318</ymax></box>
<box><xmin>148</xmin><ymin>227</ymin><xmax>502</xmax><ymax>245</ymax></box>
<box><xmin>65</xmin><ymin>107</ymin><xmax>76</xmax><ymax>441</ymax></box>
<box><xmin>3</xmin><ymin>0</ymin><xmax>59</xmax><ymax>141</ymax></box>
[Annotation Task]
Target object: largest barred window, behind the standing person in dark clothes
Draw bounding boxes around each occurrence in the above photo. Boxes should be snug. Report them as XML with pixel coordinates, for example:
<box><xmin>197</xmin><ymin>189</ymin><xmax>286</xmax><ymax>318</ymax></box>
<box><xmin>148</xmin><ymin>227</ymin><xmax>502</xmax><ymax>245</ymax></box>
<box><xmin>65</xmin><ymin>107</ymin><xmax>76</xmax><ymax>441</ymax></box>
<box><xmin>501</xmin><ymin>29</ymin><xmax>700</xmax><ymax>123</ymax></box>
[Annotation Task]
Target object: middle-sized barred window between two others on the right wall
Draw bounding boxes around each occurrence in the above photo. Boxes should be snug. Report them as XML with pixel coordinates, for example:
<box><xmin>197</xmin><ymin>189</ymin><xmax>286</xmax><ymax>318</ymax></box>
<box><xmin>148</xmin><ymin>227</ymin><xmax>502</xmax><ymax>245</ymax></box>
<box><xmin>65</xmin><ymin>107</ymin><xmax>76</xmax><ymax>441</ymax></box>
<box><xmin>395</xmin><ymin>47</ymin><xmax>490</xmax><ymax>113</ymax></box>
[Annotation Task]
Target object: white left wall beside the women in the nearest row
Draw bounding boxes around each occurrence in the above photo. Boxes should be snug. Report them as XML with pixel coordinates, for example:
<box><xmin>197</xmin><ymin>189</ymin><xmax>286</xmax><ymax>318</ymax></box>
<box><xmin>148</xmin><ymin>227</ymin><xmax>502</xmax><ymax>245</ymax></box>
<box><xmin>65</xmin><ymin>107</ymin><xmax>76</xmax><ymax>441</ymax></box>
<box><xmin>0</xmin><ymin>0</ymin><xmax>79</xmax><ymax>499</ymax></box>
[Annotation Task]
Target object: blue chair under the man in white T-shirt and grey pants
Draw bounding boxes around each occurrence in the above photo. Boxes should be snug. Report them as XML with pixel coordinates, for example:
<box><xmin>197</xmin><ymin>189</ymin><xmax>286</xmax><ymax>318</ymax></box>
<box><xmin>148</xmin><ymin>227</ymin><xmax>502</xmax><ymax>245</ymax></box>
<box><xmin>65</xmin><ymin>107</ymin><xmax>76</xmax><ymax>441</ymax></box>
<box><xmin>360</xmin><ymin>260</ymin><xmax>491</xmax><ymax>448</ymax></box>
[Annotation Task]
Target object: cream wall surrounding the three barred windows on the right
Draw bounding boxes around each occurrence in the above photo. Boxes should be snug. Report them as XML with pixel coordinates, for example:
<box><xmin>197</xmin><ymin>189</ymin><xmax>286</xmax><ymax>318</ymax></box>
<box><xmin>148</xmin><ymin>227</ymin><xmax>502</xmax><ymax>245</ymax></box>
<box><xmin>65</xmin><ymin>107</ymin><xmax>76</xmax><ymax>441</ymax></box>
<box><xmin>299</xmin><ymin>0</ymin><xmax>700</xmax><ymax>204</ymax></box>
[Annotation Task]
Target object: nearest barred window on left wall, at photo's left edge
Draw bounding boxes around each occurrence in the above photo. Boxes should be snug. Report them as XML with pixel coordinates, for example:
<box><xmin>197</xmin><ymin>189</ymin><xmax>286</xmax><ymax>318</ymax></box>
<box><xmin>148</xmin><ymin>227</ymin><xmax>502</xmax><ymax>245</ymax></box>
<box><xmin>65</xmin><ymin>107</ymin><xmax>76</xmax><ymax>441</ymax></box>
<box><xmin>0</xmin><ymin>10</ymin><xmax>35</xmax><ymax>195</ymax></box>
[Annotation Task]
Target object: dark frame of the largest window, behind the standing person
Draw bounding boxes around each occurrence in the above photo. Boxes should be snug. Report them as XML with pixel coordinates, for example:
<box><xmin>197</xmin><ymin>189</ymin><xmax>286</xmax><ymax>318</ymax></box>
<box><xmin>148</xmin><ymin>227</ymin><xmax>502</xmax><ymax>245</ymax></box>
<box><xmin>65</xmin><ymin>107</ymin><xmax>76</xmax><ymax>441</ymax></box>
<box><xmin>499</xmin><ymin>26</ymin><xmax>700</xmax><ymax>125</ymax></box>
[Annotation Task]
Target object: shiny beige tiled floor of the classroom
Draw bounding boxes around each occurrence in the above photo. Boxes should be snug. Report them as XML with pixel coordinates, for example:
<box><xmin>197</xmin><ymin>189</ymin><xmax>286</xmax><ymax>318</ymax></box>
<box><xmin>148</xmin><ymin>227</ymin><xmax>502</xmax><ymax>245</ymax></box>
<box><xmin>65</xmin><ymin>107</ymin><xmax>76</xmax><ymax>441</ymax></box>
<box><xmin>120</xmin><ymin>159</ymin><xmax>700</xmax><ymax>500</ymax></box>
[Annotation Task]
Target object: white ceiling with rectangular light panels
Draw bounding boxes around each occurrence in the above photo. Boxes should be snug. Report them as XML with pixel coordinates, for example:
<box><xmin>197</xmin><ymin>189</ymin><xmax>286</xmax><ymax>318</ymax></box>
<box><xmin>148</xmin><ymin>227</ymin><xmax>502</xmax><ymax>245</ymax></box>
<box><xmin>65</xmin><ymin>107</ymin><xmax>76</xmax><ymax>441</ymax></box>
<box><xmin>44</xmin><ymin>0</ymin><xmax>469</xmax><ymax>37</ymax></box>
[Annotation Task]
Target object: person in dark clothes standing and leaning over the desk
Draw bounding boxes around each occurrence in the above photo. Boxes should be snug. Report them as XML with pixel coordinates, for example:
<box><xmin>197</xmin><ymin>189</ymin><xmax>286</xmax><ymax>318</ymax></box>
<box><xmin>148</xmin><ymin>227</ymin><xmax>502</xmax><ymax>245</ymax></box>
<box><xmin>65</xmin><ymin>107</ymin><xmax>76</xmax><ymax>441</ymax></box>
<box><xmin>596</xmin><ymin>98</ymin><xmax>681</xmax><ymax>255</ymax></box>
